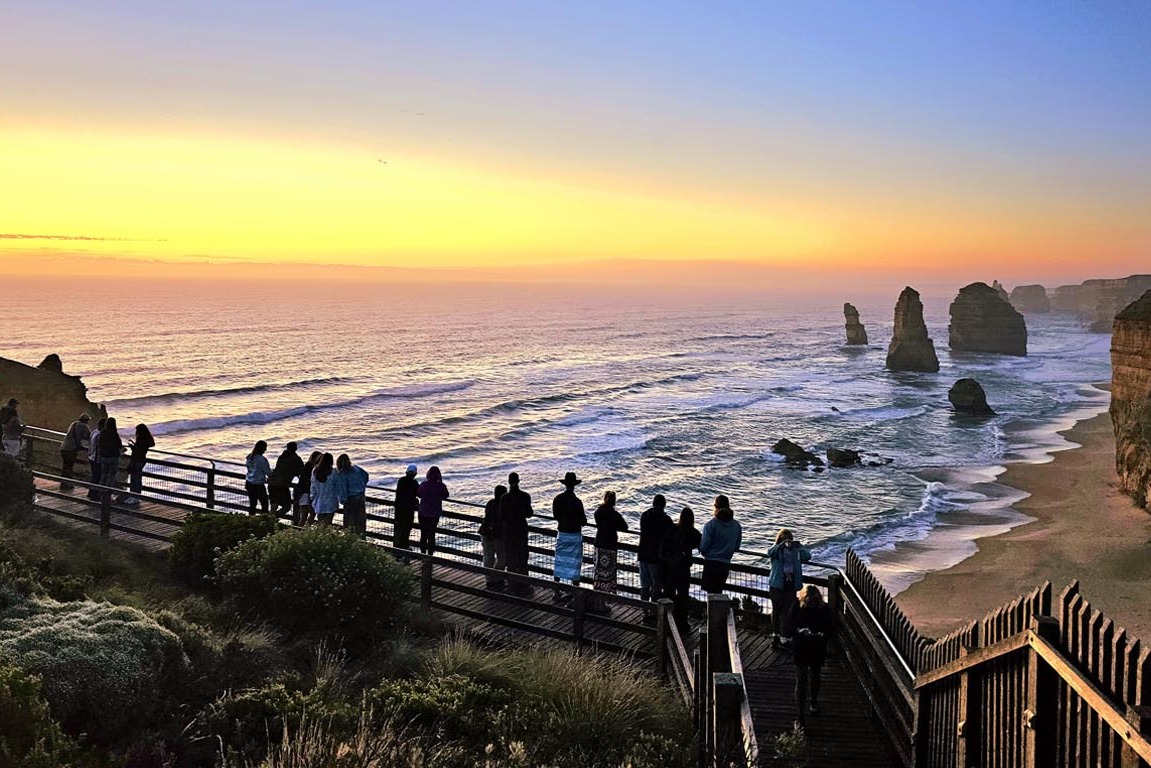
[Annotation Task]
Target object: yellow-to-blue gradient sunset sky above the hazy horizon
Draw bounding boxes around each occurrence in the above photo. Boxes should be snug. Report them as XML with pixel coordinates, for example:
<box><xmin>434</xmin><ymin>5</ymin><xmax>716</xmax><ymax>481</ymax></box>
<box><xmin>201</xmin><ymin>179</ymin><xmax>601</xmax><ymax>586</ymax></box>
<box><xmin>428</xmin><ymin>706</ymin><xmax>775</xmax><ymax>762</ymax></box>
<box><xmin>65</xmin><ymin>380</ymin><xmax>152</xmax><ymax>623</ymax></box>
<box><xmin>0</xmin><ymin>0</ymin><xmax>1151</xmax><ymax>285</ymax></box>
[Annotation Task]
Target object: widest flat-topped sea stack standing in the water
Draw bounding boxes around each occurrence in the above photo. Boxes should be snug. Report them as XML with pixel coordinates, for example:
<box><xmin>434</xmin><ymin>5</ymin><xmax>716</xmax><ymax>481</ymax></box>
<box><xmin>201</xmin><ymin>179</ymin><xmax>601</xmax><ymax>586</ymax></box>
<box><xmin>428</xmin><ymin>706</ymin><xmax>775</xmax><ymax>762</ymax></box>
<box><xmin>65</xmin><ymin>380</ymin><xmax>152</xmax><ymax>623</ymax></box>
<box><xmin>947</xmin><ymin>282</ymin><xmax>1027</xmax><ymax>356</ymax></box>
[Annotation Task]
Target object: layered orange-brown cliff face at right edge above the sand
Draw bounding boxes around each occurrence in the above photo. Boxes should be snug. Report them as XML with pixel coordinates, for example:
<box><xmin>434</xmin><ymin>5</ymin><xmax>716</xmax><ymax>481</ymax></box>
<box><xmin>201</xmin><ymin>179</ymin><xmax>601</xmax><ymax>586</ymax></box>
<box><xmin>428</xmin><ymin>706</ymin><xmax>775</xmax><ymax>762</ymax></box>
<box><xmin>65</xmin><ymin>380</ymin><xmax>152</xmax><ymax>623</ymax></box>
<box><xmin>1111</xmin><ymin>290</ymin><xmax>1151</xmax><ymax>507</ymax></box>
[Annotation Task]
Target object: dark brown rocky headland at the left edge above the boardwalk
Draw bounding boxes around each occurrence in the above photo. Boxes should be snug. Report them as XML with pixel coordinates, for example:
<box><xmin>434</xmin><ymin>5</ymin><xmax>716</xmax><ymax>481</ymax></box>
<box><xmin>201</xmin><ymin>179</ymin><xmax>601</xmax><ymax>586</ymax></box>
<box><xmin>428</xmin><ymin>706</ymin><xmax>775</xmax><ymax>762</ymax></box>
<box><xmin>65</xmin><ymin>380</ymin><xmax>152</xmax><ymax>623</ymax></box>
<box><xmin>0</xmin><ymin>355</ymin><xmax>107</xmax><ymax>432</ymax></box>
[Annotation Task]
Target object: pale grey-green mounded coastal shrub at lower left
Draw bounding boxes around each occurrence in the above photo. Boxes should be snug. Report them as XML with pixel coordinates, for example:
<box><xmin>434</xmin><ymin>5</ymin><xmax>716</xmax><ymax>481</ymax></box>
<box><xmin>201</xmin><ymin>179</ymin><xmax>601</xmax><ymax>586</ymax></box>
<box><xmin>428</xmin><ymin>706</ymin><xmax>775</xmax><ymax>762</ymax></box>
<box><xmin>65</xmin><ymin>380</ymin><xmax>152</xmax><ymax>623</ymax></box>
<box><xmin>0</xmin><ymin>598</ymin><xmax>188</xmax><ymax>744</ymax></box>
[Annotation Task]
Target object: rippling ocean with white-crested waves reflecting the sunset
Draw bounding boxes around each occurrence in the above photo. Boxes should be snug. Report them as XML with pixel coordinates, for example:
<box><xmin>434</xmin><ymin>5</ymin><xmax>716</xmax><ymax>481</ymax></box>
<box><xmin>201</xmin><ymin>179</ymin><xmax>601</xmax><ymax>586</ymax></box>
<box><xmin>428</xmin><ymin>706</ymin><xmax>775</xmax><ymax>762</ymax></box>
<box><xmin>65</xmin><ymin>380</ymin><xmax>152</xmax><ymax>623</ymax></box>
<box><xmin>0</xmin><ymin>279</ymin><xmax>1111</xmax><ymax>588</ymax></box>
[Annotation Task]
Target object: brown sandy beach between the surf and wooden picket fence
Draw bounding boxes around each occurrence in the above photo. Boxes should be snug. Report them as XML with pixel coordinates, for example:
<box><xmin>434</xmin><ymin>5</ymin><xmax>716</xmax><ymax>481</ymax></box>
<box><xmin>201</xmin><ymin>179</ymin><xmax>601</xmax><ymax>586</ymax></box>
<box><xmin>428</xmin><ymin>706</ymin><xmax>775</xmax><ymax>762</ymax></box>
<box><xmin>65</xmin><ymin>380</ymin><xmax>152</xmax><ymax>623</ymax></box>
<box><xmin>894</xmin><ymin>413</ymin><xmax>1151</xmax><ymax>640</ymax></box>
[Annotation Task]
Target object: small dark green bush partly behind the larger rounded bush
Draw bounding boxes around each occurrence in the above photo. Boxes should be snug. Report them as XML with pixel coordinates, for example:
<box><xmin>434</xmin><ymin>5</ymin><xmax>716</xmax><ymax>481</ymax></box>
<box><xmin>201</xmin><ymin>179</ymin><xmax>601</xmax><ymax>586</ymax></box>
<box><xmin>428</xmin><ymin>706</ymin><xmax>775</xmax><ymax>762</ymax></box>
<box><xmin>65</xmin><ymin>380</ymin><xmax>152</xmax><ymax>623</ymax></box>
<box><xmin>168</xmin><ymin>512</ymin><xmax>280</xmax><ymax>587</ymax></box>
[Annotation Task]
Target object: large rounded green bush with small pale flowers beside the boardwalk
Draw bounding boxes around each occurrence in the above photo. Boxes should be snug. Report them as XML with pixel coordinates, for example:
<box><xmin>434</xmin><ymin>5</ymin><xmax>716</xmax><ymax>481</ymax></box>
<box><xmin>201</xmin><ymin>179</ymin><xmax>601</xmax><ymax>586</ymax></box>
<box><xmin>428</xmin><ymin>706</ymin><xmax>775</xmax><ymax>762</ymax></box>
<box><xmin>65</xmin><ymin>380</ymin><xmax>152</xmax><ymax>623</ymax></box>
<box><xmin>216</xmin><ymin>527</ymin><xmax>412</xmax><ymax>648</ymax></box>
